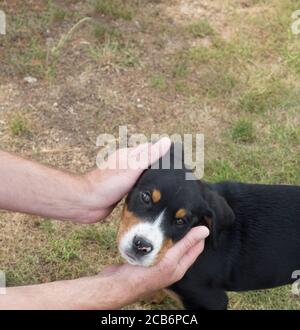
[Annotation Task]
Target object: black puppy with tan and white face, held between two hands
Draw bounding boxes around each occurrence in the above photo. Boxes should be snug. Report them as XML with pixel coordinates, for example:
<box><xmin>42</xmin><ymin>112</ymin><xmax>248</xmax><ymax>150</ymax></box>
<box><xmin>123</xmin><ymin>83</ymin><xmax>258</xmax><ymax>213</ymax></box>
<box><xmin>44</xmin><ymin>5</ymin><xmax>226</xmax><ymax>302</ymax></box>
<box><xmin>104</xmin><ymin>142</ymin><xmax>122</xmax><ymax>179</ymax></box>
<box><xmin>118</xmin><ymin>144</ymin><xmax>300</xmax><ymax>309</ymax></box>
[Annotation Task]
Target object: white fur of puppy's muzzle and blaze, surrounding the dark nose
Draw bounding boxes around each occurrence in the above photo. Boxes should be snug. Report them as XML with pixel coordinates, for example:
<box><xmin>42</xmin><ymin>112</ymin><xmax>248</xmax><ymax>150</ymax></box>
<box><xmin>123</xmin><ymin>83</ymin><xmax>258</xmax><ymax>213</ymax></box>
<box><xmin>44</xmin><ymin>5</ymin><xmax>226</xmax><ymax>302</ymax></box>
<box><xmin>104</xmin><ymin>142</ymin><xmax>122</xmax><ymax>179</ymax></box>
<box><xmin>119</xmin><ymin>210</ymin><xmax>165</xmax><ymax>266</ymax></box>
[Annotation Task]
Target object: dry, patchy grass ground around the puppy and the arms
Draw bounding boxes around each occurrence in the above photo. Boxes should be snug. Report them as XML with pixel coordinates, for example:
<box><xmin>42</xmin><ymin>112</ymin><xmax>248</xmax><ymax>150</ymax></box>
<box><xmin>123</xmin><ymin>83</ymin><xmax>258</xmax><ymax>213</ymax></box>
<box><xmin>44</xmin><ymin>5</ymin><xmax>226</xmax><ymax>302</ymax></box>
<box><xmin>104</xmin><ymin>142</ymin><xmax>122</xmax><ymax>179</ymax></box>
<box><xmin>0</xmin><ymin>0</ymin><xmax>300</xmax><ymax>309</ymax></box>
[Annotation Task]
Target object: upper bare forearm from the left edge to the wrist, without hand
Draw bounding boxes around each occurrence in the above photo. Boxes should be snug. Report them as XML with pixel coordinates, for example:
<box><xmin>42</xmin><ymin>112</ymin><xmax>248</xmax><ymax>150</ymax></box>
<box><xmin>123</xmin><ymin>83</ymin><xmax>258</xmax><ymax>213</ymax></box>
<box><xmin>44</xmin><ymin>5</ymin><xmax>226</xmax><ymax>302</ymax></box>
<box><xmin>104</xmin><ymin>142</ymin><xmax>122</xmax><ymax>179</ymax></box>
<box><xmin>0</xmin><ymin>151</ymin><xmax>95</xmax><ymax>220</ymax></box>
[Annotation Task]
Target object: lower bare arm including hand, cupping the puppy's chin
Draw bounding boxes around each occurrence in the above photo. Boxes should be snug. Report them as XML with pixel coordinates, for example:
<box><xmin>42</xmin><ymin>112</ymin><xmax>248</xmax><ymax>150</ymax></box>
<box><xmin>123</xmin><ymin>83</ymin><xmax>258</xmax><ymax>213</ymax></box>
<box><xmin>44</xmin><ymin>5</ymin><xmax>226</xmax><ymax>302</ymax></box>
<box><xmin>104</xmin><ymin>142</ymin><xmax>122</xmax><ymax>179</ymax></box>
<box><xmin>0</xmin><ymin>227</ymin><xmax>209</xmax><ymax>309</ymax></box>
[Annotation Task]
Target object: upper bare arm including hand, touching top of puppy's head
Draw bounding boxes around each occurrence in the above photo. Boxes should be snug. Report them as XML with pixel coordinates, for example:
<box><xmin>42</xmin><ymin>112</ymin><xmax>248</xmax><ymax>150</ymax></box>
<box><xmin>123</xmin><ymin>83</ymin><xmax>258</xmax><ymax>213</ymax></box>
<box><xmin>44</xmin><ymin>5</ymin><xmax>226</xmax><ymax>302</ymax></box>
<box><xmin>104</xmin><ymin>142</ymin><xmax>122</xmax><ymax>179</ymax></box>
<box><xmin>0</xmin><ymin>138</ymin><xmax>170</xmax><ymax>223</ymax></box>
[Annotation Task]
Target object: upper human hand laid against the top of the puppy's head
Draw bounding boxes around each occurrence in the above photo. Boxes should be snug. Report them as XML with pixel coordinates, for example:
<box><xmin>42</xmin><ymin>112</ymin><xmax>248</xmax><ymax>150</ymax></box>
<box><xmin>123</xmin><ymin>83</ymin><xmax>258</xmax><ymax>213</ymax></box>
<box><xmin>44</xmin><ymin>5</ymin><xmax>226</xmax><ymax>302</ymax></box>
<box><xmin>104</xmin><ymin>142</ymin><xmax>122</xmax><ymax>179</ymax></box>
<box><xmin>76</xmin><ymin>138</ymin><xmax>171</xmax><ymax>223</ymax></box>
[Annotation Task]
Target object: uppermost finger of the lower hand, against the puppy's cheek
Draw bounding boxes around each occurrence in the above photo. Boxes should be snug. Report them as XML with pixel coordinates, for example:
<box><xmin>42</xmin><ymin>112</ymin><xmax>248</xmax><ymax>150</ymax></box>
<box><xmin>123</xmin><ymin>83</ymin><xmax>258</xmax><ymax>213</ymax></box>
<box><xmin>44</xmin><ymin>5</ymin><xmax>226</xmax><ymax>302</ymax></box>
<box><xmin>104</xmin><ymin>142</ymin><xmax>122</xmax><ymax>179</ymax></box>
<box><xmin>165</xmin><ymin>226</ymin><xmax>209</xmax><ymax>262</ymax></box>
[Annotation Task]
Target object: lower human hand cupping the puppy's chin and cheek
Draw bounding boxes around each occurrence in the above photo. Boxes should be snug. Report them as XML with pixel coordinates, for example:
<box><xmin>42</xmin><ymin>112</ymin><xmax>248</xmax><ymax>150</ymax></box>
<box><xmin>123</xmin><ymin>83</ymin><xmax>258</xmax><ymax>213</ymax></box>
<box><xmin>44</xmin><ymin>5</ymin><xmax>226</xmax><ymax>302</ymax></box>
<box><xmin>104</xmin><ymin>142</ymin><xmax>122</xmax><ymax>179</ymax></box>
<box><xmin>89</xmin><ymin>226</ymin><xmax>209</xmax><ymax>309</ymax></box>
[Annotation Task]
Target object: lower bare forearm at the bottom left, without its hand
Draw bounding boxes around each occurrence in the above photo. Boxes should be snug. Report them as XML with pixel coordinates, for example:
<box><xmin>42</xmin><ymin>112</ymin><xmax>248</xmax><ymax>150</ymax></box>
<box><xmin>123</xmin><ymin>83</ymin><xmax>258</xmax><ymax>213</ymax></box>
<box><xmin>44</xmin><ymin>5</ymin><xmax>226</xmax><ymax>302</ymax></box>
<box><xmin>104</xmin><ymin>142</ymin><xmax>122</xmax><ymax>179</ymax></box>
<box><xmin>0</xmin><ymin>276</ymin><xmax>128</xmax><ymax>310</ymax></box>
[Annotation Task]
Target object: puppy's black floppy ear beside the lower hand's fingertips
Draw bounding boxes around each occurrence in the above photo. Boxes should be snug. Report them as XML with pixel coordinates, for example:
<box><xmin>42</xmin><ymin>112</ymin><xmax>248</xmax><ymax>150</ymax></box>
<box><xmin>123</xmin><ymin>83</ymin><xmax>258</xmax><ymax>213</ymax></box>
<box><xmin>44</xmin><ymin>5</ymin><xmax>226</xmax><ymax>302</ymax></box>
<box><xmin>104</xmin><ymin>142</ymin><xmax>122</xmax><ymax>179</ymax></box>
<box><xmin>201</xmin><ymin>188</ymin><xmax>235</xmax><ymax>249</ymax></box>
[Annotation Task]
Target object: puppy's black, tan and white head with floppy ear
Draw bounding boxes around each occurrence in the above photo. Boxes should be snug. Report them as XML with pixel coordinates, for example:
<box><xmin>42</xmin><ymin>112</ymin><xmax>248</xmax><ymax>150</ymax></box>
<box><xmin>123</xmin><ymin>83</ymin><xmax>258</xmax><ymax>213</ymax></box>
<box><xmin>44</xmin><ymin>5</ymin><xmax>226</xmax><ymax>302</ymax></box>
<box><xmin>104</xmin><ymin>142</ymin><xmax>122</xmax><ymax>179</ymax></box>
<box><xmin>118</xmin><ymin>146</ymin><xmax>234</xmax><ymax>266</ymax></box>
